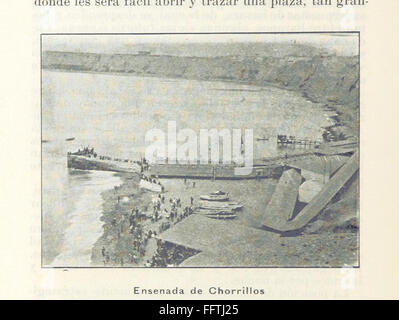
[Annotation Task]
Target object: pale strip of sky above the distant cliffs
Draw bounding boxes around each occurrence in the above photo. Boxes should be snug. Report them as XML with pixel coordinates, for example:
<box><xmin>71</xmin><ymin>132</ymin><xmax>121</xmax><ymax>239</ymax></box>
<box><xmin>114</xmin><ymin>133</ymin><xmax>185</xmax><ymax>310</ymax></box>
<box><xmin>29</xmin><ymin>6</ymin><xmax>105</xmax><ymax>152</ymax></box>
<box><xmin>42</xmin><ymin>33</ymin><xmax>359</xmax><ymax>56</ymax></box>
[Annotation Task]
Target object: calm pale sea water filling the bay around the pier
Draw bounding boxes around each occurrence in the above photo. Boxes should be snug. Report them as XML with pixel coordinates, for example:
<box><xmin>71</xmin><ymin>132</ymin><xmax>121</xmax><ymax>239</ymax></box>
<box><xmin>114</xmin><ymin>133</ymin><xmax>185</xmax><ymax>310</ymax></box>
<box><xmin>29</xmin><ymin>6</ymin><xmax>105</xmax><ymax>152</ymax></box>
<box><xmin>42</xmin><ymin>70</ymin><xmax>331</xmax><ymax>267</ymax></box>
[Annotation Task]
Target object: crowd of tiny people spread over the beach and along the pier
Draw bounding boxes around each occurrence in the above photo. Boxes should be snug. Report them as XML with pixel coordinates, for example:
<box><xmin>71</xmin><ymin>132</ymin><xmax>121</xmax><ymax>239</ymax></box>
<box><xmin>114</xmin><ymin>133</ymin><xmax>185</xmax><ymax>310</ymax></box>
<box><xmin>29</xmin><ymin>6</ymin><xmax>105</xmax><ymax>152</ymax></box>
<box><xmin>68</xmin><ymin>147</ymin><xmax>199</xmax><ymax>267</ymax></box>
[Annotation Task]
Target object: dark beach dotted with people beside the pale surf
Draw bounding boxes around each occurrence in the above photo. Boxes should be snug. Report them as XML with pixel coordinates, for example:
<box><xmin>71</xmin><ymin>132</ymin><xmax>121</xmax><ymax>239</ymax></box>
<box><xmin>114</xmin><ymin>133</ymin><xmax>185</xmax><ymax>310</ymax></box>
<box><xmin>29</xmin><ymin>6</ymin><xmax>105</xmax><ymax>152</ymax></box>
<box><xmin>91</xmin><ymin>173</ymin><xmax>202</xmax><ymax>267</ymax></box>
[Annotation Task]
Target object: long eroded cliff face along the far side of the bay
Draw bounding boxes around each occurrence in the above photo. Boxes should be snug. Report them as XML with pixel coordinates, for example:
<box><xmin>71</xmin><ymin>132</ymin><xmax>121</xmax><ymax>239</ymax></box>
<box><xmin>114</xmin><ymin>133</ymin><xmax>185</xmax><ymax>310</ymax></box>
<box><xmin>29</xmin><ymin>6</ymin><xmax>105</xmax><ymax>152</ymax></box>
<box><xmin>42</xmin><ymin>51</ymin><xmax>359</xmax><ymax>106</ymax></box>
